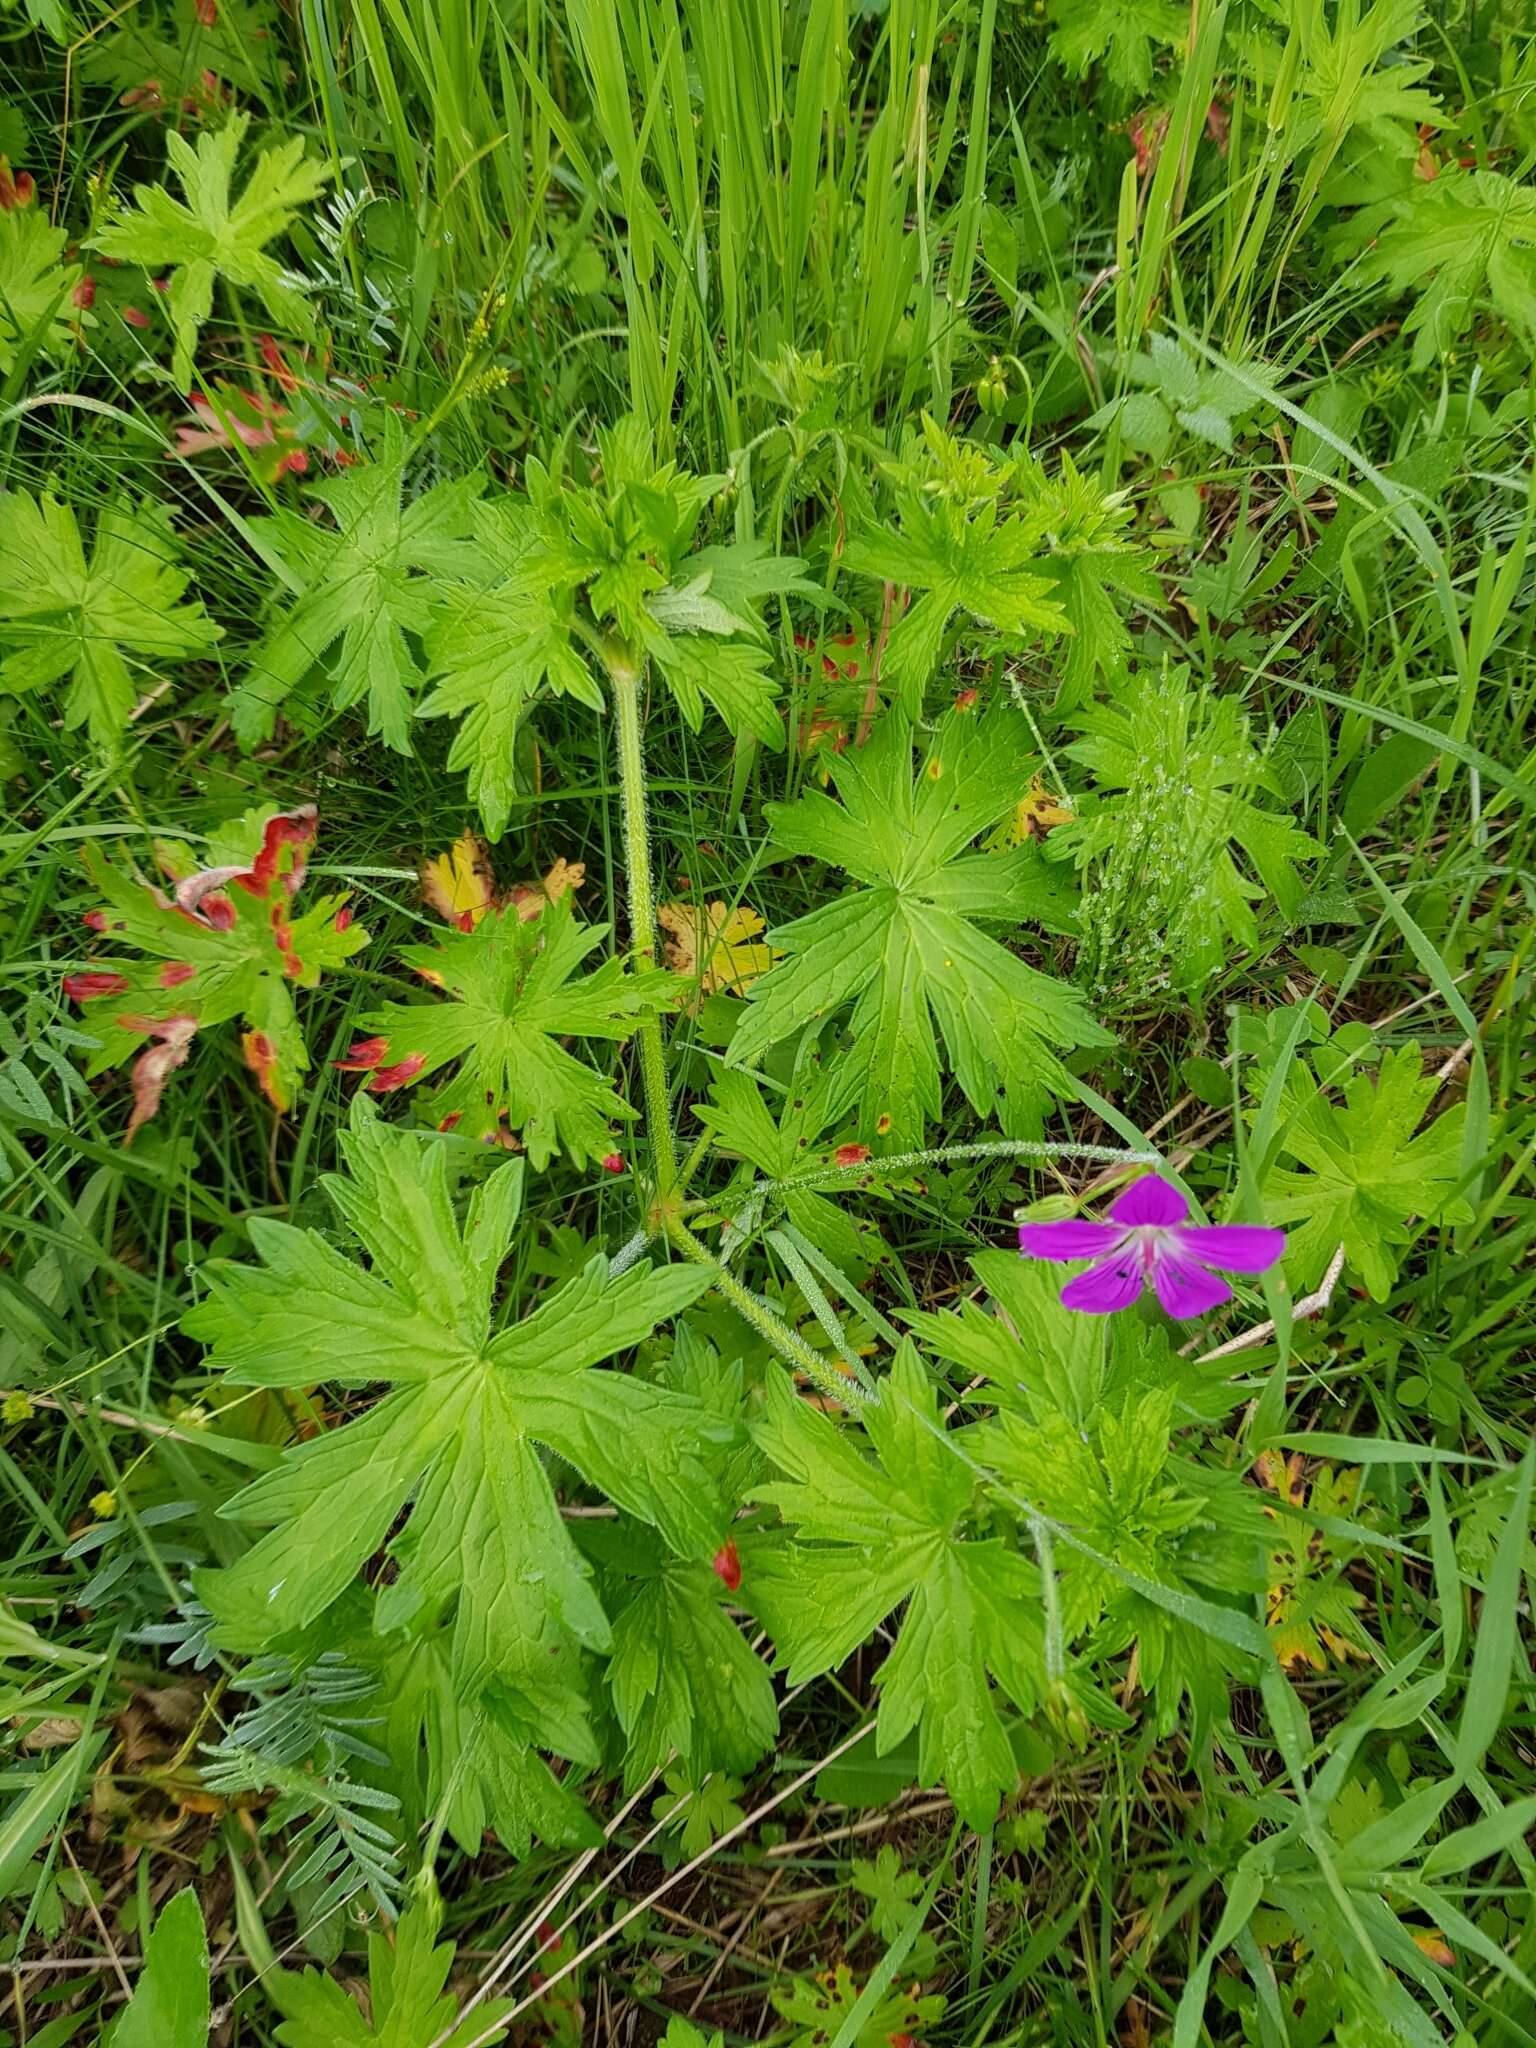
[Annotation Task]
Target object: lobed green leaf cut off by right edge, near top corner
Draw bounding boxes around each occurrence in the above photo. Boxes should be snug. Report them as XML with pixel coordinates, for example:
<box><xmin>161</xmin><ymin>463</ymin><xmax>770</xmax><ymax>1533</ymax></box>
<box><xmin>1350</xmin><ymin>168</ymin><xmax>1536</xmax><ymax>369</ymax></box>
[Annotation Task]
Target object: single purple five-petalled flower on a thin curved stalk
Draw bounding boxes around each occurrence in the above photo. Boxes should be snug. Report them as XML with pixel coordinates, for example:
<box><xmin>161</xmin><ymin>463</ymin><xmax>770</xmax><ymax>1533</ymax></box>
<box><xmin>1018</xmin><ymin>1174</ymin><xmax>1286</xmax><ymax>1321</ymax></box>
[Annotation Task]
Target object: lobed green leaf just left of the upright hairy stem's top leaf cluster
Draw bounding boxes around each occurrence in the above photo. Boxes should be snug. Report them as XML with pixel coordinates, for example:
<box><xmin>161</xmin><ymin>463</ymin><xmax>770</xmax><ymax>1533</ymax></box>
<box><xmin>229</xmin><ymin>414</ymin><xmax>479</xmax><ymax>754</ymax></box>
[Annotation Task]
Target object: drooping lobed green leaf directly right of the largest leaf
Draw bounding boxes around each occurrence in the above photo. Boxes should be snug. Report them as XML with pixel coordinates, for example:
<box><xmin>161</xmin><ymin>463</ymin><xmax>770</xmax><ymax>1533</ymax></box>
<box><xmin>741</xmin><ymin>1343</ymin><xmax>1044</xmax><ymax>1827</ymax></box>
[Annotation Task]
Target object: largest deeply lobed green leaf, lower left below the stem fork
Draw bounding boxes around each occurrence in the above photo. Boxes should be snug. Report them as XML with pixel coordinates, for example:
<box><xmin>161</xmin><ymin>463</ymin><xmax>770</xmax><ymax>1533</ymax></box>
<box><xmin>186</xmin><ymin>1100</ymin><xmax>731</xmax><ymax>1735</ymax></box>
